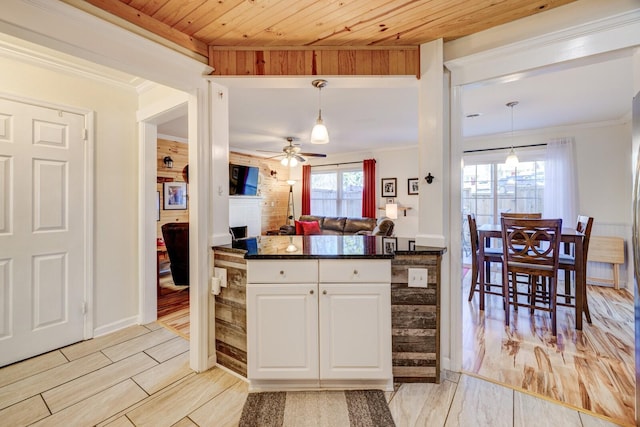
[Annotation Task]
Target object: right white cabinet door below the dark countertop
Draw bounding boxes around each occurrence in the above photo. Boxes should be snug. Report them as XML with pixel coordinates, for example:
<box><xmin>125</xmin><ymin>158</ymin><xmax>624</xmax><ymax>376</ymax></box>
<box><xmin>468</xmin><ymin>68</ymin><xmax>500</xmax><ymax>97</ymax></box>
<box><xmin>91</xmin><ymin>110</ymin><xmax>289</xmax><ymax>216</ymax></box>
<box><xmin>319</xmin><ymin>283</ymin><xmax>392</xmax><ymax>380</ymax></box>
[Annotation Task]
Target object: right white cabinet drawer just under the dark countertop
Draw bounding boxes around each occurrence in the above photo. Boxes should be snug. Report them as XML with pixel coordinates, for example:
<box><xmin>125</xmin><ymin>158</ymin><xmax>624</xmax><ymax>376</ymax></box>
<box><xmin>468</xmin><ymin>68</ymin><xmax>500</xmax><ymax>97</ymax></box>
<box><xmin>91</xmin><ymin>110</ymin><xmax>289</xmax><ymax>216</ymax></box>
<box><xmin>320</xmin><ymin>259</ymin><xmax>391</xmax><ymax>283</ymax></box>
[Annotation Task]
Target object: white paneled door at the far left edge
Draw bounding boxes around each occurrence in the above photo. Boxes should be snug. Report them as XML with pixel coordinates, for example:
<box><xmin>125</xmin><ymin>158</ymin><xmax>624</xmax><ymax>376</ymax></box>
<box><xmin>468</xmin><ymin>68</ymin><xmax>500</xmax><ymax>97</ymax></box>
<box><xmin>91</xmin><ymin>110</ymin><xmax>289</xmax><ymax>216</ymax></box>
<box><xmin>0</xmin><ymin>98</ymin><xmax>87</xmax><ymax>366</ymax></box>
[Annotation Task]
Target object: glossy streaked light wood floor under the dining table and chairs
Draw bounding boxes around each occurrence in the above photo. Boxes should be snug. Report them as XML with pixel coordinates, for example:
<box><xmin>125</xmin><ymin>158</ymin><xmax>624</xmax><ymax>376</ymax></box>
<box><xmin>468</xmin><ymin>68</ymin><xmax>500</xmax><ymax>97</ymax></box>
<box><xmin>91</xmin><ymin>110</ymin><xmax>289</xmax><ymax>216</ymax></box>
<box><xmin>462</xmin><ymin>274</ymin><xmax>635</xmax><ymax>425</ymax></box>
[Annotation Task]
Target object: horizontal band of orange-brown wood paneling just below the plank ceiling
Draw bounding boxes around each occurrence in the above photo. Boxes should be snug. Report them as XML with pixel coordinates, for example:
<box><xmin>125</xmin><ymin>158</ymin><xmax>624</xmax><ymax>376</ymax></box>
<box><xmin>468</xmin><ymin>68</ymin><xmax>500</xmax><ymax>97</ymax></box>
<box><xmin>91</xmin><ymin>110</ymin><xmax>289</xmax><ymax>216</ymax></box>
<box><xmin>209</xmin><ymin>46</ymin><xmax>420</xmax><ymax>77</ymax></box>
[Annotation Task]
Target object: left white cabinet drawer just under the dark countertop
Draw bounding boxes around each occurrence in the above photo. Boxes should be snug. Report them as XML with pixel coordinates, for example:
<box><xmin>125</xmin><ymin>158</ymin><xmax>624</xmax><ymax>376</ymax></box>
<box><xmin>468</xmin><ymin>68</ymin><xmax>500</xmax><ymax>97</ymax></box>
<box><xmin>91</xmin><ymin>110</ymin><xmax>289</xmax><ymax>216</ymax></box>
<box><xmin>247</xmin><ymin>259</ymin><xmax>318</xmax><ymax>283</ymax></box>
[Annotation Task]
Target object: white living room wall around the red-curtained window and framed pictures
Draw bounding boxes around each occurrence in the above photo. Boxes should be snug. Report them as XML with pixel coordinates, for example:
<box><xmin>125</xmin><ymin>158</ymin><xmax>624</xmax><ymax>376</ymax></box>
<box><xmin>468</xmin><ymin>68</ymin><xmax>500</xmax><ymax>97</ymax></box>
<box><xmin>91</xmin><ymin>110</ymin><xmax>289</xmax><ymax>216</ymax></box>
<box><xmin>308</xmin><ymin>146</ymin><xmax>426</xmax><ymax>238</ymax></box>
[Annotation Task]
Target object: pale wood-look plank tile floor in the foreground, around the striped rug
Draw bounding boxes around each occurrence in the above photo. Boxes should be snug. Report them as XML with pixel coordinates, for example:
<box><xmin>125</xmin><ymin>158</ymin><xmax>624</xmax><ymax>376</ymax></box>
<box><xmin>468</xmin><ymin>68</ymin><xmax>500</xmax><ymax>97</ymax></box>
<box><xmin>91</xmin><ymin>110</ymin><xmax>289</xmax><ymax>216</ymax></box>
<box><xmin>0</xmin><ymin>323</ymin><xmax>615</xmax><ymax>427</ymax></box>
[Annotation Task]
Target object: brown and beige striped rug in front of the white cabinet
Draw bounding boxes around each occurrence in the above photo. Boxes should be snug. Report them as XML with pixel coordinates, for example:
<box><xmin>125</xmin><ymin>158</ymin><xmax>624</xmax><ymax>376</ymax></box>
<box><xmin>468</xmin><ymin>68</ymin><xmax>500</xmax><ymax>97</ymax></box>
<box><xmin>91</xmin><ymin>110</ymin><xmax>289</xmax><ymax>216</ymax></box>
<box><xmin>239</xmin><ymin>390</ymin><xmax>395</xmax><ymax>427</ymax></box>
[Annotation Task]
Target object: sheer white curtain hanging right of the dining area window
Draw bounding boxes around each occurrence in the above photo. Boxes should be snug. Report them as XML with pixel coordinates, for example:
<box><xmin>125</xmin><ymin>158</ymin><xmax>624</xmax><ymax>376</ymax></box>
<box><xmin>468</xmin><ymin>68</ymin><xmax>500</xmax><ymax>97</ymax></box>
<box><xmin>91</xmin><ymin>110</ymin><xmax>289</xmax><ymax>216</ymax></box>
<box><xmin>543</xmin><ymin>138</ymin><xmax>578</xmax><ymax>227</ymax></box>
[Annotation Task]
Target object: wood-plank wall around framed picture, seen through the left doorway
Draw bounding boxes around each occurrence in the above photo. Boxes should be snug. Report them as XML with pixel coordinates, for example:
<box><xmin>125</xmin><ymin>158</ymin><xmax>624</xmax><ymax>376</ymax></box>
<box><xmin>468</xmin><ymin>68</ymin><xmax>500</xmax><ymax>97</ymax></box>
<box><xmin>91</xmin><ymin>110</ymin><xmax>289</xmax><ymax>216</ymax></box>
<box><xmin>156</xmin><ymin>139</ymin><xmax>189</xmax><ymax>237</ymax></box>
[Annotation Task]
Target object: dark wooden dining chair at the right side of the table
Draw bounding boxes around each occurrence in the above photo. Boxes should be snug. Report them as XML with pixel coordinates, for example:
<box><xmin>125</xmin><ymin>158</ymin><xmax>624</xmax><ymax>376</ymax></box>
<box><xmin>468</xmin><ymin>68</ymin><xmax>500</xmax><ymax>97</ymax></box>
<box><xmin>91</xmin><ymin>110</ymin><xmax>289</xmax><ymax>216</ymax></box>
<box><xmin>558</xmin><ymin>215</ymin><xmax>593</xmax><ymax>323</ymax></box>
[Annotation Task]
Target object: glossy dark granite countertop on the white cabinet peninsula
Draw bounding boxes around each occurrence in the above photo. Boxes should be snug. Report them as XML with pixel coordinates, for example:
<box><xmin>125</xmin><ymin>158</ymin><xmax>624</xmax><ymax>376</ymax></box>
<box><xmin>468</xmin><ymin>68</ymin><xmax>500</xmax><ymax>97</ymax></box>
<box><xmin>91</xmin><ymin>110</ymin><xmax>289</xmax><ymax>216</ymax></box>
<box><xmin>214</xmin><ymin>235</ymin><xmax>446</xmax><ymax>259</ymax></box>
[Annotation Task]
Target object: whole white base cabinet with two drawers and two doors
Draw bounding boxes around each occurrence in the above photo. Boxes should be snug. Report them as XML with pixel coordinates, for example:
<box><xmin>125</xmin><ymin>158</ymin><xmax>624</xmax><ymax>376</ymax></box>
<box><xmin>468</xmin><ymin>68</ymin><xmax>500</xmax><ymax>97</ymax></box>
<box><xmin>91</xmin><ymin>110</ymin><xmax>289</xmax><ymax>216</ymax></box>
<box><xmin>247</xmin><ymin>260</ymin><xmax>393</xmax><ymax>389</ymax></box>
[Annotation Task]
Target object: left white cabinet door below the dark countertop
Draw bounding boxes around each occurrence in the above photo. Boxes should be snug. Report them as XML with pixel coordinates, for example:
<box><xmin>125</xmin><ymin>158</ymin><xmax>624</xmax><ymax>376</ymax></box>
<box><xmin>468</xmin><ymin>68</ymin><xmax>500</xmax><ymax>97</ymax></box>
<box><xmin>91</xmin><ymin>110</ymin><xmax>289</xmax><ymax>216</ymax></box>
<box><xmin>247</xmin><ymin>283</ymin><xmax>318</xmax><ymax>379</ymax></box>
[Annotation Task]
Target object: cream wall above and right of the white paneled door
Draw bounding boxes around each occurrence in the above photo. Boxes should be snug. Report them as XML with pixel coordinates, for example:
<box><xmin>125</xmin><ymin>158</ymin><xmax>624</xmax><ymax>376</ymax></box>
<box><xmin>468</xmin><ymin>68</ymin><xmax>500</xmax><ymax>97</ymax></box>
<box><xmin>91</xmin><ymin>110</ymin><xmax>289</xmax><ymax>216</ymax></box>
<box><xmin>0</xmin><ymin>58</ymin><xmax>138</xmax><ymax>330</ymax></box>
